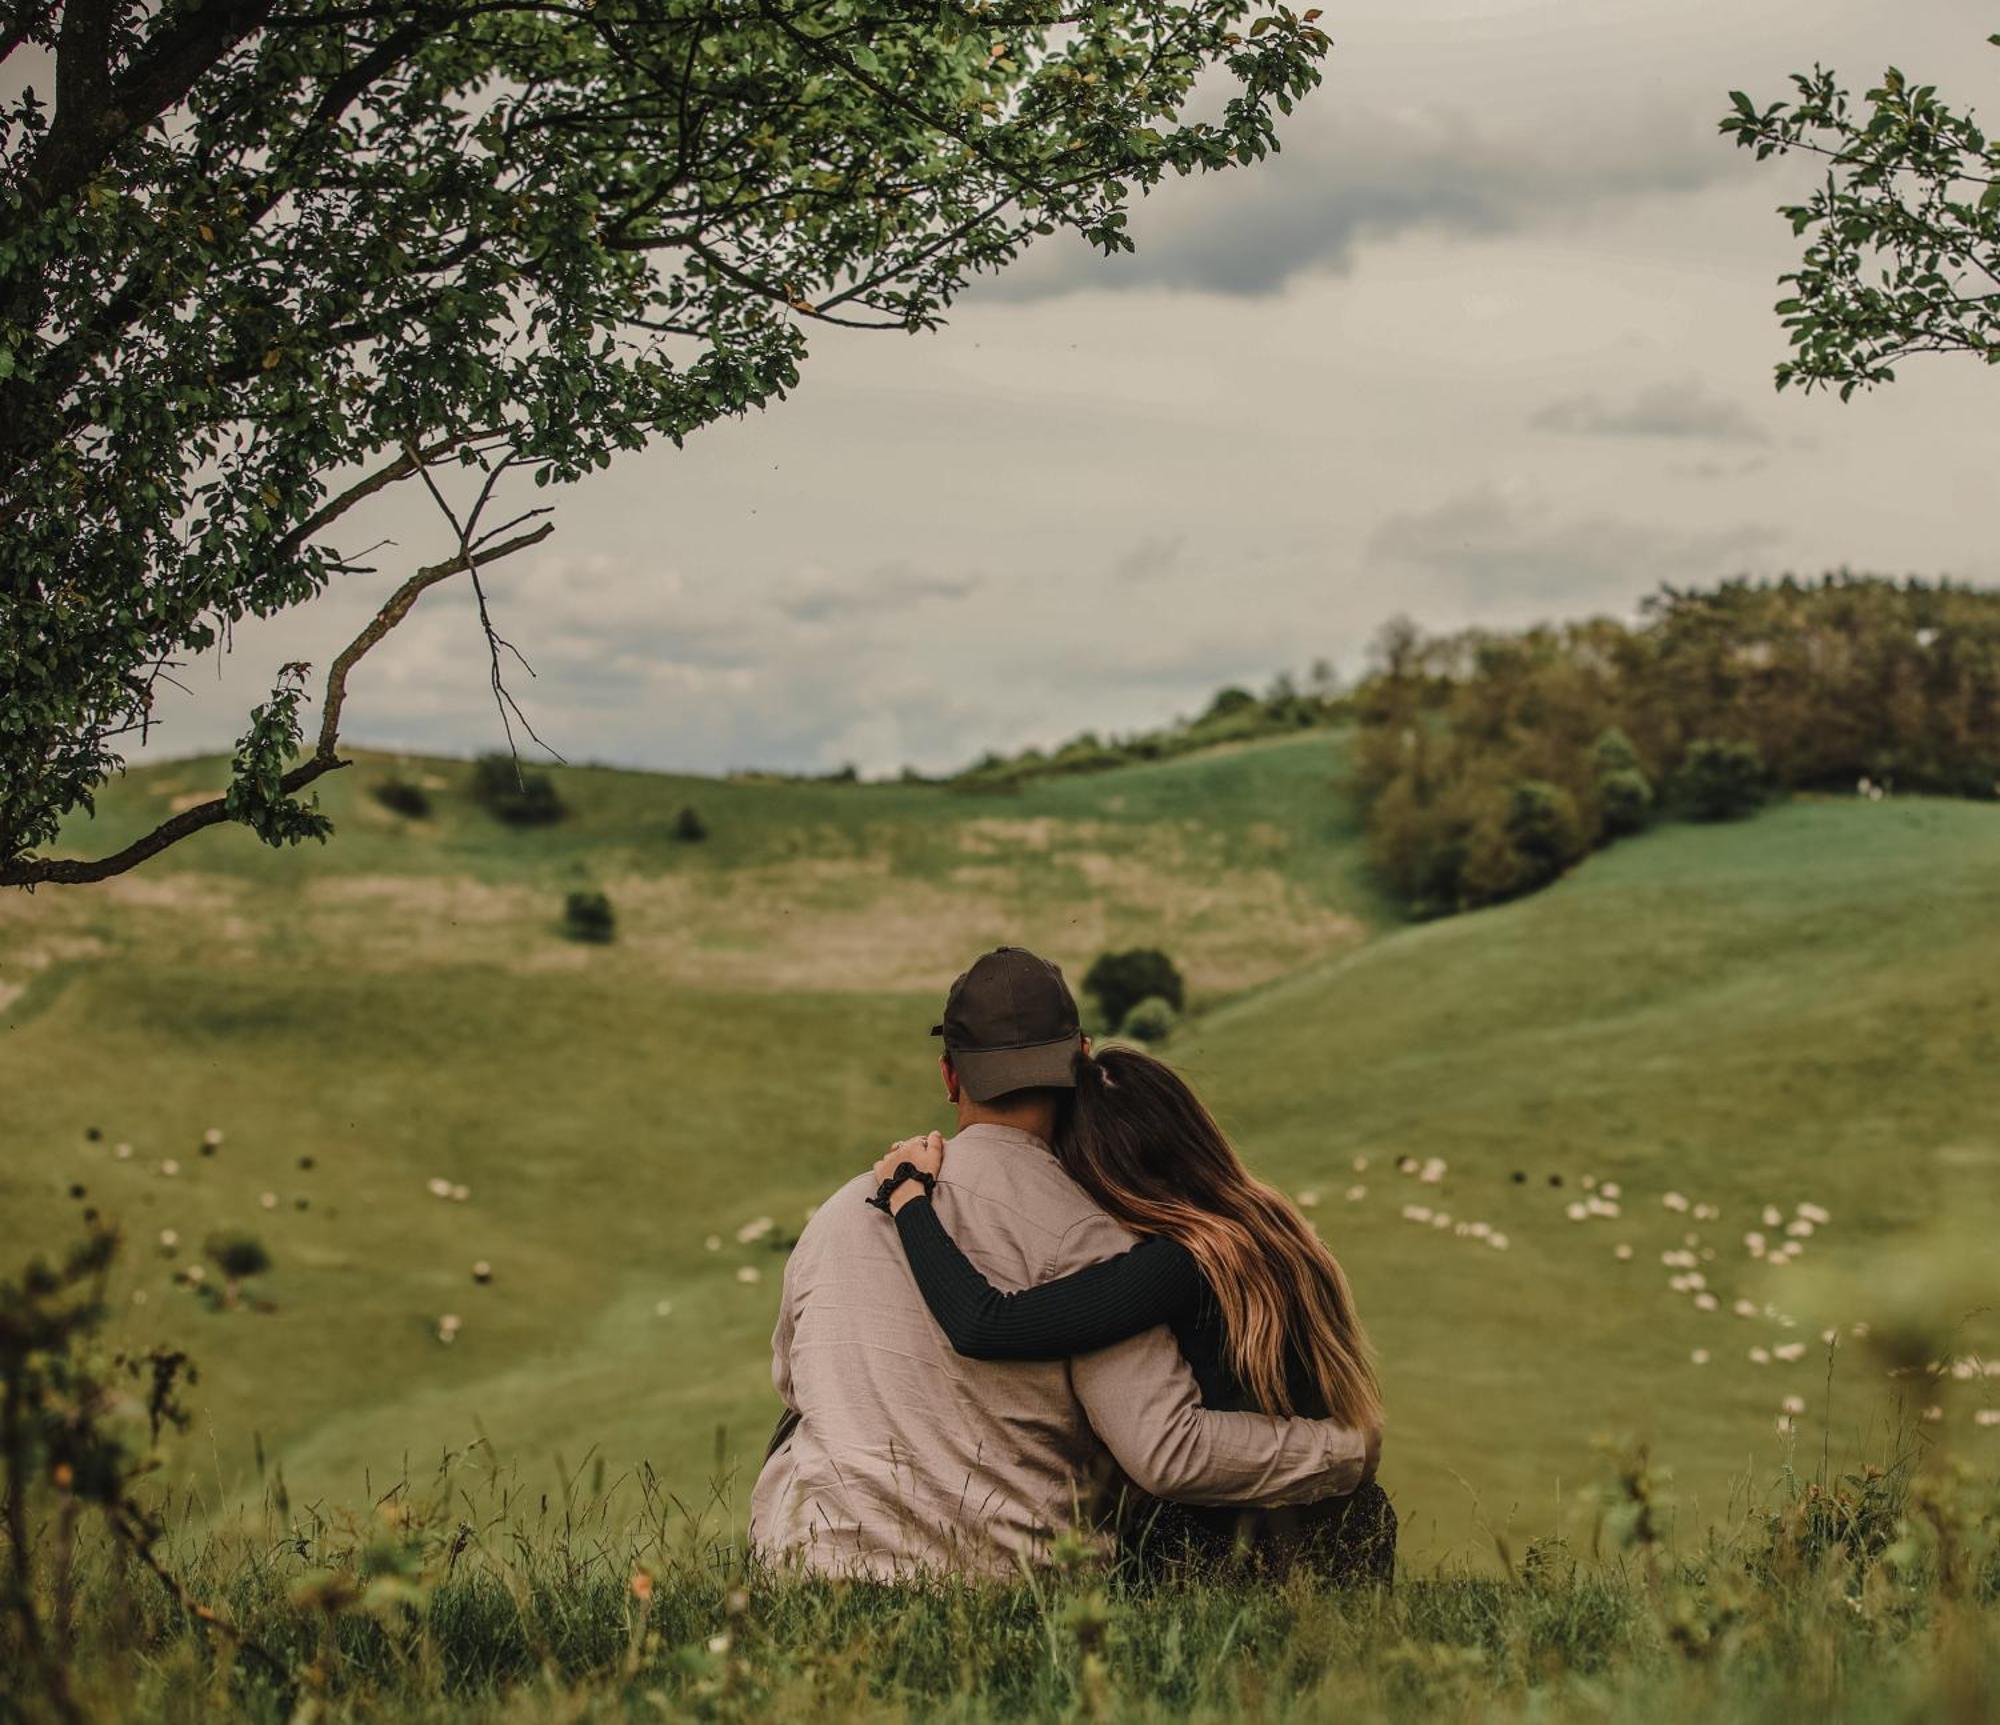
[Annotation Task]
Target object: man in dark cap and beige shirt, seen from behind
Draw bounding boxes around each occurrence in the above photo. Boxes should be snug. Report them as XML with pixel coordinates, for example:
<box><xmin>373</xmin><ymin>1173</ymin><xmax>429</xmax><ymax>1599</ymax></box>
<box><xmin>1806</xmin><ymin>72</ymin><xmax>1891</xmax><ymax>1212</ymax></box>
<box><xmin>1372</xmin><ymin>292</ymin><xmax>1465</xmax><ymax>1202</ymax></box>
<box><xmin>750</xmin><ymin>947</ymin><xmax>1374</xmax><ymax>1579</ymax></box>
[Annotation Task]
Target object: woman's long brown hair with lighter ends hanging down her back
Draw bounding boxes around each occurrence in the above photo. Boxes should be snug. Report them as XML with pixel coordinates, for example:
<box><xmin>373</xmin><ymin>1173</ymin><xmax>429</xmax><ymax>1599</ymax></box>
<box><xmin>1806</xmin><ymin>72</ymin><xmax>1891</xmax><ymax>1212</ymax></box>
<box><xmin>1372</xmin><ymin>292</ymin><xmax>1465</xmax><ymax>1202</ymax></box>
<box><xmin>1056</xmin><ymin>1047</ymin><xmax>1382</xmax><ymax>1427</ymax></box>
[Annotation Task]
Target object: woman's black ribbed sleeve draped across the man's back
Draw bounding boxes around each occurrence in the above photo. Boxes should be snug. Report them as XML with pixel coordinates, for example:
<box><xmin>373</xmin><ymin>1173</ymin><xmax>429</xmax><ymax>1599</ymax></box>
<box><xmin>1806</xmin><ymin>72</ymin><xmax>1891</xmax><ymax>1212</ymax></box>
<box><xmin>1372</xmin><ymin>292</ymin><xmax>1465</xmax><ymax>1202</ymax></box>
<box><xmin>896</xmin><ymin>1197</ymin><xmax>1206</xmax><ymax>1359</ymax></box>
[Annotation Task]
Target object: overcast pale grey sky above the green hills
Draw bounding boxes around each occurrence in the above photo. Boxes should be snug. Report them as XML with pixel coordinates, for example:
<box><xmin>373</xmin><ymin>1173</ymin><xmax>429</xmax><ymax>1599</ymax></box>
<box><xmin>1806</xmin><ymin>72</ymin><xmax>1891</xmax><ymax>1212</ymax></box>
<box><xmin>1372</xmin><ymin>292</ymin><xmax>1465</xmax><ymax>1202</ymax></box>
<box><xmin>121</xmin><ymin>0</ymin><xmax>2000</xmax><ymax>774</ymax></box>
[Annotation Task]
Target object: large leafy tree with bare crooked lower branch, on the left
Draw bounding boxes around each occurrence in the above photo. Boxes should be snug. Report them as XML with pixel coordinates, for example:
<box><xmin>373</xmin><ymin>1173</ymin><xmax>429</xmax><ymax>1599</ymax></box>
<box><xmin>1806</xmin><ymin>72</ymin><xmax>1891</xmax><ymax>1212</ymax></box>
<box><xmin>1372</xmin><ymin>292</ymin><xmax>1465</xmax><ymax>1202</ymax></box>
<box><xmin>0</xmin><ymin>0</ymin><xmax>1328</xmax><ymax>887</ymax></box>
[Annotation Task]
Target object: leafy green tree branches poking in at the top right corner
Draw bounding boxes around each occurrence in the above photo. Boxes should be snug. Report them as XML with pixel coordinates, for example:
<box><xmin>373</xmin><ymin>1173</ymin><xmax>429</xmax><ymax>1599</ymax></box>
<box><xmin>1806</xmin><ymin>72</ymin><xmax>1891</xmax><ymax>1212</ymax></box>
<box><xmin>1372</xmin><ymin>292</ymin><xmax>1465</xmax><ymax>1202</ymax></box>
<box><xmin>1722</xmin><ymin>36</ymin><xmax>2000</xmax><ymax>400</ymax></box>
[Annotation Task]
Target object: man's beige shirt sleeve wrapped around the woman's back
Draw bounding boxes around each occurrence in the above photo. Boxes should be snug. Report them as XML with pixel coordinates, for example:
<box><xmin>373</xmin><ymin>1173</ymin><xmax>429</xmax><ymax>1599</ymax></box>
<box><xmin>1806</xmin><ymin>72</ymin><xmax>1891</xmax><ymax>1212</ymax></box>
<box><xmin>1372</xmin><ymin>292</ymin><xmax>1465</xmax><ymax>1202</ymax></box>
<box><xmin>1066</xmin><ymin>1219</ymin><xmax>1378</xmax><ymax>1507</ymax></box>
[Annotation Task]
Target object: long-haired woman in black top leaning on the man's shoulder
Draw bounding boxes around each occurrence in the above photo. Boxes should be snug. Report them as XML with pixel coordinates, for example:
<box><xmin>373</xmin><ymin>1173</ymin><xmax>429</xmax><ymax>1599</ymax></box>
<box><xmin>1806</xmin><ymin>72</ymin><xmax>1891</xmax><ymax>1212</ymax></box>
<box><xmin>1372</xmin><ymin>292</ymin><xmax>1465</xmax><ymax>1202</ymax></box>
<box><xmin>876</xmin><ymin>1047</ymin><xmax>1396</xmax><ymax>1581</ymax></box>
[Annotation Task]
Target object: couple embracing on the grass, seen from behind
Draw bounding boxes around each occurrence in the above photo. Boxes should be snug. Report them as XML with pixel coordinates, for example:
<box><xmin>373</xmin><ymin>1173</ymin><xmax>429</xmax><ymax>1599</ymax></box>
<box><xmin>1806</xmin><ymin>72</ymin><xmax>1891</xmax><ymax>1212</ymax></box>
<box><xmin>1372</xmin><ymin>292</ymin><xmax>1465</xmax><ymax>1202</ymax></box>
<box><xmin>750</xmin><ymin>947</ymin><xmax>1396</xmax><ymax>1581</ymax></box>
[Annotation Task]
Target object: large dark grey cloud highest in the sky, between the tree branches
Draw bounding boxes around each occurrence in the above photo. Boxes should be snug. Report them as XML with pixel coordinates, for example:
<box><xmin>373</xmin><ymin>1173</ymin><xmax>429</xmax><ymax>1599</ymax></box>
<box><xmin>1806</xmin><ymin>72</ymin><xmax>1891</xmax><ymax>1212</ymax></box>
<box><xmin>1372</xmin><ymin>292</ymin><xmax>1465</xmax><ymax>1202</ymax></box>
<box><xmin>986</xmin><ymin>104</ymin><xmax>1738</xmax><ymax>300</ymax></box>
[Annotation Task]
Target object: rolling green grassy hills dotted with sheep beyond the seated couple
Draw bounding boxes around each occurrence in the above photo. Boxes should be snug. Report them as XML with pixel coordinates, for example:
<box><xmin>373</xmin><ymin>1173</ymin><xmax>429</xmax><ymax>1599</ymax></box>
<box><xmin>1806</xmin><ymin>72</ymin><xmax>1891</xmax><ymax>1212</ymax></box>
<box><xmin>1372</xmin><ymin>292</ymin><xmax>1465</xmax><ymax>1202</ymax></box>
<box><xmin>0</xmin><ymin>732</ymin><xmax>2000</xmax><ymax>1576</ymax></box>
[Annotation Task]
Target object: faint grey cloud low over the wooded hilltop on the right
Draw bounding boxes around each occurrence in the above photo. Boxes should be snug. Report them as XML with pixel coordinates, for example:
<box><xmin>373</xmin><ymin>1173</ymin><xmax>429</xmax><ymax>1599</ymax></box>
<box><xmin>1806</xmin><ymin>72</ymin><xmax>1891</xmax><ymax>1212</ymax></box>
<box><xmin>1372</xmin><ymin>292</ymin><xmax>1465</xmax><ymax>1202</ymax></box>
<box><xmin>1368</xmin><ymin>486</ymin><xmax>1778</xmax><ymax>604</ymax></box>
